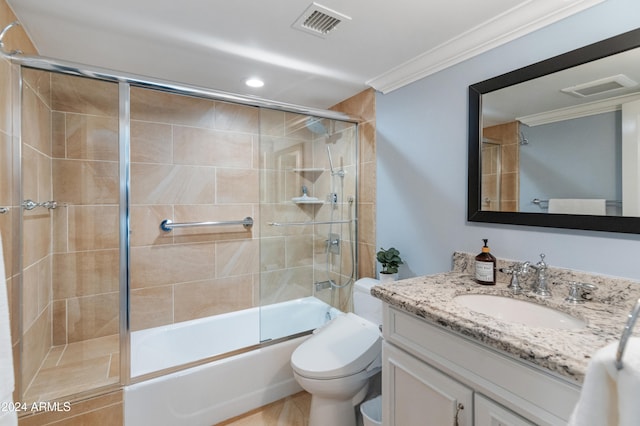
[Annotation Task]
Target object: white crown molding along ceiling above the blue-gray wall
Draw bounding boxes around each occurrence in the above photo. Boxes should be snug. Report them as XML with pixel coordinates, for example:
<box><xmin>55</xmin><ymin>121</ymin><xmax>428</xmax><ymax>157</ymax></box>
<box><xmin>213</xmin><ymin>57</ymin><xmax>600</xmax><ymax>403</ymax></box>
<box><xmin>366</xmin><ymin>0</ymin><xmax>606</xmax><ymax>93</ymax></box>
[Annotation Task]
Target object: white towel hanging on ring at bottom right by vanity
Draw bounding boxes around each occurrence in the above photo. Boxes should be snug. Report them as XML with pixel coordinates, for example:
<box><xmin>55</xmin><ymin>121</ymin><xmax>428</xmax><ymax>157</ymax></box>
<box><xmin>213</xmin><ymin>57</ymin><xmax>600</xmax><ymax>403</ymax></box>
<box><xmin>569</xmin><ymin>337</ymin><xmax>640</xmax><ymax>426</ymax></box>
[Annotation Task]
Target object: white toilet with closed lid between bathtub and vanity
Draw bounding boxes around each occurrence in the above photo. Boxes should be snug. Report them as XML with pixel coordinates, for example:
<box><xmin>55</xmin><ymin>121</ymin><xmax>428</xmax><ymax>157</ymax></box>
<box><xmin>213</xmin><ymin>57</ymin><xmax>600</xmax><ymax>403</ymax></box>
<box><xmin>291</xmin><ymin>278</ymin><xmax>382</xmax><ymax>426</ymax></box>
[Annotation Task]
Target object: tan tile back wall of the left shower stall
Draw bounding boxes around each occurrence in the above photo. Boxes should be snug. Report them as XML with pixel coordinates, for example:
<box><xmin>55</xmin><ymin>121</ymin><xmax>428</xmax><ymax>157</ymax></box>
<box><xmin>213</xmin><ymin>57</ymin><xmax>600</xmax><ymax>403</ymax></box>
<box><xmin>50</xmin><ymin>73</ymin><xmax>119</xmax><ymax>345</ymax></box>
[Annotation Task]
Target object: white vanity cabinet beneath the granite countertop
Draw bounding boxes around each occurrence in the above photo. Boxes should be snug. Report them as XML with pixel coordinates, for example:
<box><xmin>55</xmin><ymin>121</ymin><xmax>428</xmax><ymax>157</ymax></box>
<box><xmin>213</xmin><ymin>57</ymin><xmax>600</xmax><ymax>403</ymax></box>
<box><xmin>382</xmin><ymin>304</ymin><xmax>580</xmax><ymax>426</ymax></box>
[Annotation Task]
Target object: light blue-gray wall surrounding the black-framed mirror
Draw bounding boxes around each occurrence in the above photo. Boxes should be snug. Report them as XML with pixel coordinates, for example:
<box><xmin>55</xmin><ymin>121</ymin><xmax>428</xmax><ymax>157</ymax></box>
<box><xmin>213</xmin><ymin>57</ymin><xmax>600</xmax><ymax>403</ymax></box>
<box><xmin>376</xmin><ymin>0</ymin><xmax>640</xmax><ymax>280</ymax></box>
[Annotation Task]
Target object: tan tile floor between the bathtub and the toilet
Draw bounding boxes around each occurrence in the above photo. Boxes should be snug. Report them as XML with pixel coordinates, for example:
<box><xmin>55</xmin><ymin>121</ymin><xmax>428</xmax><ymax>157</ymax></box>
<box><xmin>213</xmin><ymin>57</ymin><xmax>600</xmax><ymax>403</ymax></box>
<box><xmin>215</xmin><ymin>391</ymin><xmax>311</xmax><ymax>426</ymax></box>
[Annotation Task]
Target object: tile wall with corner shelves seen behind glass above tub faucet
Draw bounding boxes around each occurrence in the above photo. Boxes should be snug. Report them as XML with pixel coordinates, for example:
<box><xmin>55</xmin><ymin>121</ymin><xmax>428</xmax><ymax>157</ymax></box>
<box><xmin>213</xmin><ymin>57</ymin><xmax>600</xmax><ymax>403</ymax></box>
<box><xmin>260</xmin><ymin>111</ymin><xmax>357</xmax><ymax>308</ymax></box>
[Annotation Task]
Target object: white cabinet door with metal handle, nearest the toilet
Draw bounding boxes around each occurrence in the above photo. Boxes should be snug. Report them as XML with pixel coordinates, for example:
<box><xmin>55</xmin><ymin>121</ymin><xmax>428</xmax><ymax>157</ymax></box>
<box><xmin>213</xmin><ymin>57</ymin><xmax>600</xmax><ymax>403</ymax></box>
<box><xmin>382</xmin><ymin>342</ymin><xmax>473</xmax><ymax>426</ymax></box>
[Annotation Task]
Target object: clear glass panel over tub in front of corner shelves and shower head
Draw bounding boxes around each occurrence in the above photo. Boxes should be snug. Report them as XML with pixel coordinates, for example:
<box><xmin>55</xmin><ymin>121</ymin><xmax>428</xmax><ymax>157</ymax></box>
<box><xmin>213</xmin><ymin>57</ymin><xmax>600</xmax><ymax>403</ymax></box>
<box><xmin>259</xmin><ymin>110</ymin><xmax>358</xmax><ymax>341</ymax></box>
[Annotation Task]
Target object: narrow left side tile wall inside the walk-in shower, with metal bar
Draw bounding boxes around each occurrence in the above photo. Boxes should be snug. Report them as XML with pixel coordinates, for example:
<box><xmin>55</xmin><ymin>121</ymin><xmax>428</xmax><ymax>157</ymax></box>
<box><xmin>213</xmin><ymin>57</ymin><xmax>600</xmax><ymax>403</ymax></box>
<box><xmin>20</xmin><ymin>70</ymin><xmax>53</xmax><ymax>396</ymax></box>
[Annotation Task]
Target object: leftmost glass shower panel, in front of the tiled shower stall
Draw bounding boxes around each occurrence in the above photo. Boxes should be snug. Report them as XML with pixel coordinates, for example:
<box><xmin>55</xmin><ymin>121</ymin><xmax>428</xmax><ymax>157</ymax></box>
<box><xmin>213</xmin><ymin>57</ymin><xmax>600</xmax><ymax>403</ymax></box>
<box><xmin>20</xmin><ymin>68</ymin><xmax>120</xmax><ymax>402</ymax></box>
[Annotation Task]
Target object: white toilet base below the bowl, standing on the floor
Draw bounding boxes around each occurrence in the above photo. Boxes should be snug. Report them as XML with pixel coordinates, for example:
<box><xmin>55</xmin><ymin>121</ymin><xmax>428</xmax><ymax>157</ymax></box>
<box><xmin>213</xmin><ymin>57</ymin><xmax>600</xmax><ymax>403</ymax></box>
<box><xmin>309</xmin><ymin>382</ymin><xmax>369</xmax><ymax>426</ymax></box>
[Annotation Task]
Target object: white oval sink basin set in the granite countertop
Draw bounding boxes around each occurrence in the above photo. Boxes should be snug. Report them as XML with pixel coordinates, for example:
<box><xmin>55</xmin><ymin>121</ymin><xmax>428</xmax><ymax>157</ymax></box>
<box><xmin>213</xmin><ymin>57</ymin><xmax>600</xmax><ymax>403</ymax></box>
<box><xmin>454</xmin><ymin>294</ymin><xmax>586</xmax><ymax>330</ymax></box>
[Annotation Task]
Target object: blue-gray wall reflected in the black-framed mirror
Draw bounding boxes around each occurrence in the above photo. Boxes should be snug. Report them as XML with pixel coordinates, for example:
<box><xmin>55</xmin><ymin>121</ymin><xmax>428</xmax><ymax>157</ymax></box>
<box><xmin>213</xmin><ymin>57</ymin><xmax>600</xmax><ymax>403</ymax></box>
<box><xmin>520</xmin><ymin>111</ymin><xmax>620</xmax><ymax>213</ymax></box>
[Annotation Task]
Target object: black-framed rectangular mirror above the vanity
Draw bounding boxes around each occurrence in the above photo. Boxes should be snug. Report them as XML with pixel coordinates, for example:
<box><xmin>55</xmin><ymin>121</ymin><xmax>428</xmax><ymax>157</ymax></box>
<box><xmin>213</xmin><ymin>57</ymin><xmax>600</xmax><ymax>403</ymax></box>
<box><xmin>467</xmin><ymin>29</ymin><xmax>640</xmax><ymax>233</ymax></box>
